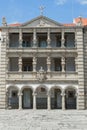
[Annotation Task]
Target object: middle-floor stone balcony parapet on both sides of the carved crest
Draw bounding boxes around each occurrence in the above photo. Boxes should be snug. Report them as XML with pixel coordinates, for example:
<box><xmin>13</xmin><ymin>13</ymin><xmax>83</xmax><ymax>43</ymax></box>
<box><xmin>6</xmin><ymin>71</ymin><xmax>78</xmax><ymax>81</ymax></box>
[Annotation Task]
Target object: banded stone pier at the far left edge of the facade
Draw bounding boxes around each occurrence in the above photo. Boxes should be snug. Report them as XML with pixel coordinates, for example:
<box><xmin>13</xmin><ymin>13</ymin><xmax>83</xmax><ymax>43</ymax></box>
<box><xmin>0</xmin><ymin>30</ymin><xmax>6</xmax><ymax>109</ymax></box>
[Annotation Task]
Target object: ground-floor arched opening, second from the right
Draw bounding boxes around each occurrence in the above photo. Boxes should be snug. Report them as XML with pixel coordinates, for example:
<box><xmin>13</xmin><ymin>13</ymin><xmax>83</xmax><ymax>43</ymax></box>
<box><xmin>51</xmin><ymin>88</ymin><xmax>62</xmax><ymax>109</ymax></box>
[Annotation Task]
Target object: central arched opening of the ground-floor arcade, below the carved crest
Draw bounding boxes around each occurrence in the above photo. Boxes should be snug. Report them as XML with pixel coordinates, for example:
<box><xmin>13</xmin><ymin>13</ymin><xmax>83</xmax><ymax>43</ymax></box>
<box><xmin>36</xmin><ymin>87</ymin><xmax>47</xmax><ymax>109</ymax></box>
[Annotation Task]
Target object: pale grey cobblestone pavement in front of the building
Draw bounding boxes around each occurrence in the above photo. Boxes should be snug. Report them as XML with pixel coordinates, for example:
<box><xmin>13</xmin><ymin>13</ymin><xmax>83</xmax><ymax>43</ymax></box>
<box><xmin>0</xmin><ymin>110</ymin><xmax>87</xmax><ymax>130</ymax></box>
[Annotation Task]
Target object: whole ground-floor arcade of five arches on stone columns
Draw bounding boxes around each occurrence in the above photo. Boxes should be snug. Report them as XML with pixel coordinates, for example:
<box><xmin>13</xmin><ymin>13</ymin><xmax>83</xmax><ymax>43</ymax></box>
<box><xmin>6</xmin><ymin>85</ymin><xmax>77</xmax><ymax>110</ymax></box>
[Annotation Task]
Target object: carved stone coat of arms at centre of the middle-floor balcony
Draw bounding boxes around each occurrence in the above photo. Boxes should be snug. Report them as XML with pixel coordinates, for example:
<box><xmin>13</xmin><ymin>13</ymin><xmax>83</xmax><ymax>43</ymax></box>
<box><xmin>37</xmin><ymin>67</ymin><xmax>46</xmax><ymax>82</ymax></box>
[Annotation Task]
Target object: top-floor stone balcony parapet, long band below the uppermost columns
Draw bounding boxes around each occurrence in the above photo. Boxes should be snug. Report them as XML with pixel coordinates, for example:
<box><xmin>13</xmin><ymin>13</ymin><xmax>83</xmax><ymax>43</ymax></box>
<box><xmin>7</xmin><ymin>47</ymin><xmax>77</xmax><ymax>53</ymax></box>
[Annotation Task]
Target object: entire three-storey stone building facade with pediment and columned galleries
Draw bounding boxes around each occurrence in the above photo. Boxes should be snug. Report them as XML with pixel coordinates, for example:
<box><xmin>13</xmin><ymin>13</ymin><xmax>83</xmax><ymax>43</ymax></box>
<box><xmin>0</xmin><ymin>16</ymin><xmax>87</xmax><ymax>110</ymax></box>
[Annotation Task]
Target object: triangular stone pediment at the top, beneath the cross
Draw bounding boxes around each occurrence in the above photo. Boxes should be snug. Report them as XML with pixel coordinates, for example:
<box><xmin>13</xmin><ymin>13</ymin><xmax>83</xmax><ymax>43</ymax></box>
<box><xmin>22</xmin><ymin>16</ymin><xmax>63</xmax><ymax>27</ymax></box>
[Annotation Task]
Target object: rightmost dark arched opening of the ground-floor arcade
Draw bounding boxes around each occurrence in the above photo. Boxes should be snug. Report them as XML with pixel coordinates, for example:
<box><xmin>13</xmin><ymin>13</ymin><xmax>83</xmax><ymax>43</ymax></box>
<box><xmin>65</xmin><ymin>88</ymin><xmax>76</xmax><ymax>109</ymax></box>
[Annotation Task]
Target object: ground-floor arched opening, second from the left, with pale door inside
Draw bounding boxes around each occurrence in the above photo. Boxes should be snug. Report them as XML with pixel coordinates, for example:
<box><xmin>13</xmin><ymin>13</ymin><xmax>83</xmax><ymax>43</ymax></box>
<box><xmin>22</xmin><ymin>88</ymin><xmax>33</xmax><ymax>109</ymax></box>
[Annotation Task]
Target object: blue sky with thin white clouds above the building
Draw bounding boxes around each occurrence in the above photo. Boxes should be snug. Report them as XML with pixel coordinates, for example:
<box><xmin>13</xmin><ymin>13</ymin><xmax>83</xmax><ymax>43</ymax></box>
<box><xmin>0</xmin><ymin>0</ymin><xmax>87</xmax><ymax>25</ymax></box>
